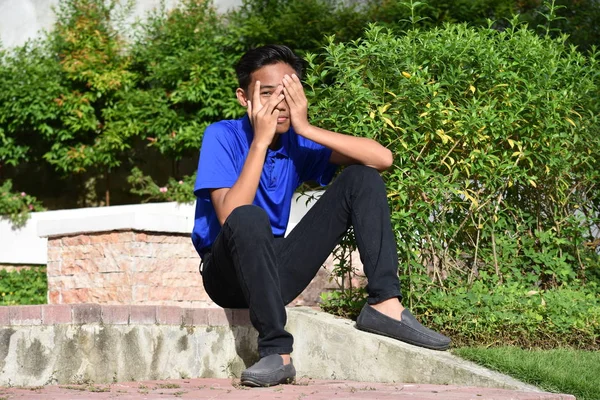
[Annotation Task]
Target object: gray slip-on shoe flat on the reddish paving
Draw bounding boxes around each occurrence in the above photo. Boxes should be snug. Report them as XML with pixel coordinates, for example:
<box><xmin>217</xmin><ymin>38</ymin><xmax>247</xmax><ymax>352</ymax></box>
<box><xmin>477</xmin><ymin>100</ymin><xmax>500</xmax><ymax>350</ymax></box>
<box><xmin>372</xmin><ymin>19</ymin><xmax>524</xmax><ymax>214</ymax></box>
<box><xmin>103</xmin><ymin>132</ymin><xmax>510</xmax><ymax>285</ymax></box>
<box><xmin>241</xmin><ymin>354</ymin><xmax>296</xmax><ymax>387</ymax></box>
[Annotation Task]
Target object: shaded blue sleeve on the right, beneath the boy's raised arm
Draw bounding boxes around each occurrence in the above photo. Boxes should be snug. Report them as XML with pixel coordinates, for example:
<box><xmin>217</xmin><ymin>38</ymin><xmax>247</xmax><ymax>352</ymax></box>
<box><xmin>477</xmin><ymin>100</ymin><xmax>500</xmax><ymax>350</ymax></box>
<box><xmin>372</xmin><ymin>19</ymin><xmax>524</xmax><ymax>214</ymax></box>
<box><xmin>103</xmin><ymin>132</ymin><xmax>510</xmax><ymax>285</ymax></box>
<box><xmin>299</xmin><ymin>138</ymin><xmax>338</xmax><ymax>186</ymax></box>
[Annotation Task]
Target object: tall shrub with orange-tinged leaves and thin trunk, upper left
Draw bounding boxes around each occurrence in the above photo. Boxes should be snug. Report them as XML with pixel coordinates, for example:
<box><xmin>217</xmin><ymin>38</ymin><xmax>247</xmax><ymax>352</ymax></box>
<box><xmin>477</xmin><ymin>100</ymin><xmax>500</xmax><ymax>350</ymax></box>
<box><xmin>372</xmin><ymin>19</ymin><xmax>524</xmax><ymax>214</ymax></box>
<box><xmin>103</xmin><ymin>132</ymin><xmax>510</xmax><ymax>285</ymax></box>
<box><xmin>44</xmin><ymin>0</ymin><xmax>138</xmax><ymax>200</ymax></box>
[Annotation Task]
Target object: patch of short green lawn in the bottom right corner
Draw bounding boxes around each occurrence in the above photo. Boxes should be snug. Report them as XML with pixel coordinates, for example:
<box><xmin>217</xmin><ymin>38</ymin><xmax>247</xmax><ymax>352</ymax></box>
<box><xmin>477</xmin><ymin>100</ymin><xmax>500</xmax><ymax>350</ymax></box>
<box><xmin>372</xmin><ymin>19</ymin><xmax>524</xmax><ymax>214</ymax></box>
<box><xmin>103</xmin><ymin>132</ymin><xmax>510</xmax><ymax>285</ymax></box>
<box><xmin>453</xmin><ymin>347</ymin><xmax>600</xmax><ymax>400</ymax></box>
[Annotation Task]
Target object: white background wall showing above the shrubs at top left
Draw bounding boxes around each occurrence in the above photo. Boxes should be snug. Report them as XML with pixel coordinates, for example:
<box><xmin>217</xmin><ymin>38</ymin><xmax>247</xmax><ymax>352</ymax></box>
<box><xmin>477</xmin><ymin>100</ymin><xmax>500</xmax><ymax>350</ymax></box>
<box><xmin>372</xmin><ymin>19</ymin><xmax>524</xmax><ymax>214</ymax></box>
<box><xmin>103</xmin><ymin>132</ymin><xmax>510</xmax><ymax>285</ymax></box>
<box><xmin>0</xmin><ymin>0</ymin><xmax>242</xmax><ymax>48</ymax></box>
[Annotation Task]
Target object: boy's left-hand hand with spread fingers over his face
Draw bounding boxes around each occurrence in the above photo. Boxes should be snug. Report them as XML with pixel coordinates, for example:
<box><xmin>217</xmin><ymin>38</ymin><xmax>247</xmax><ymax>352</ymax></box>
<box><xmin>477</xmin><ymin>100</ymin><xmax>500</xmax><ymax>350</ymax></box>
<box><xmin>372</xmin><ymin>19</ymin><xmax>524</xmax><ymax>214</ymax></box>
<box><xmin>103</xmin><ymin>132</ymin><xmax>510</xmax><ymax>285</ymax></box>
<box><xmin>248</xmin><ymin>81</ymin><xmax>285</xmax><ymax>147</ymax></box>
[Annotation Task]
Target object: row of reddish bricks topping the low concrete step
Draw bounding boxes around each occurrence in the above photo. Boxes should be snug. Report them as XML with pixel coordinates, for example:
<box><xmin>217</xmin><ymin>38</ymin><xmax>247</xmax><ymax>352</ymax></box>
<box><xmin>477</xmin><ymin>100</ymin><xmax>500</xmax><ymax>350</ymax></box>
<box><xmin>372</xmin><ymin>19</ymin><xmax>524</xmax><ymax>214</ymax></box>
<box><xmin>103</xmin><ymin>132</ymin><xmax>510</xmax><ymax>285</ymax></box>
<box><xmin>0</xmin><ymin>304</ymin><xmax>251</xmax><ymax>326</ymax></box>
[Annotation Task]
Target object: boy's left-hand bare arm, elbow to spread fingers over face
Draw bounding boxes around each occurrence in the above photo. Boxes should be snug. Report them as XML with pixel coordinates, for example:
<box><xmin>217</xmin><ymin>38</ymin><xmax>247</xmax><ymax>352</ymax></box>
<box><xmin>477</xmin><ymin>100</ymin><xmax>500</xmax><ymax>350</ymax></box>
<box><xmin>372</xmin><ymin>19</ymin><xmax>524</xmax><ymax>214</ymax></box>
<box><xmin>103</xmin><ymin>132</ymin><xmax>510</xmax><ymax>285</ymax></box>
<box><xmin>210</xmin><ymin>81</ymin><xmax>284</xmax><ymax>225</ymax></box>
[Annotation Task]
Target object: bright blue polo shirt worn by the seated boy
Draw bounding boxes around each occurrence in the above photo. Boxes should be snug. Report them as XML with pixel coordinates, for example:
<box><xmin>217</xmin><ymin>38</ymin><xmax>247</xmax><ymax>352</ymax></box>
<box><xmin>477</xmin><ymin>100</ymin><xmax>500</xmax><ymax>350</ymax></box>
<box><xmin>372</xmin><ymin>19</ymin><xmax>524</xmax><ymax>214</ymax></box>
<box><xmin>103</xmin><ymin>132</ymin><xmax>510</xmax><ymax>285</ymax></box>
<box><xmin>192</xmin><ymin>116</ymin><xmax>337</xmax><ymax>256</ymax></box>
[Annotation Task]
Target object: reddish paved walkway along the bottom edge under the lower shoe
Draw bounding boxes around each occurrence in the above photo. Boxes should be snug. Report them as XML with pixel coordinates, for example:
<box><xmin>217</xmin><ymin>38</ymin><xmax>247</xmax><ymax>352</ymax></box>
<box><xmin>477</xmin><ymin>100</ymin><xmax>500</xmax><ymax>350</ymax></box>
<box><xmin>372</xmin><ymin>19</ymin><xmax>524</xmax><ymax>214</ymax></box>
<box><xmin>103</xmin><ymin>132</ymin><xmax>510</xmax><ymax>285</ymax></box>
<box><xmin>0</xmin><ymin>379</ymin><xmax>575</xmax><ymax>400</ymax></box>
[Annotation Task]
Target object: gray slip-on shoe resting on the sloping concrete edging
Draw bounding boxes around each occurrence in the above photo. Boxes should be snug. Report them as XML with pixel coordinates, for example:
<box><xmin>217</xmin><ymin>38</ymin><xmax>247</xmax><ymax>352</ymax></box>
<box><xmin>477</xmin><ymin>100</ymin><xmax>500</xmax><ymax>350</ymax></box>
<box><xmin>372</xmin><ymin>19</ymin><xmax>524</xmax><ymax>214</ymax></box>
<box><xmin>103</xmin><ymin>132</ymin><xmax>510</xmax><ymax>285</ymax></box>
<box><xmin>356</xmin><ymin>304</ymin><xmax>450</xmax><ymax>350</ymax></box>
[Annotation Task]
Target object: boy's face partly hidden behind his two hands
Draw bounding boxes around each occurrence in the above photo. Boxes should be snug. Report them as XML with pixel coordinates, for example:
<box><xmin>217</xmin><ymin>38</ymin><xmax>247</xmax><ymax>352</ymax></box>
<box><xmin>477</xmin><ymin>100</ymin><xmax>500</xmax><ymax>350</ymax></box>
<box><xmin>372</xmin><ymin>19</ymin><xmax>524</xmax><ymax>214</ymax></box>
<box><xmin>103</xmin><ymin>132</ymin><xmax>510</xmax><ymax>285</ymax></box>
<box><xmin>238</xmin><ymin>62</ymin><xmax>296</xmax><ymax>134</ymax></box>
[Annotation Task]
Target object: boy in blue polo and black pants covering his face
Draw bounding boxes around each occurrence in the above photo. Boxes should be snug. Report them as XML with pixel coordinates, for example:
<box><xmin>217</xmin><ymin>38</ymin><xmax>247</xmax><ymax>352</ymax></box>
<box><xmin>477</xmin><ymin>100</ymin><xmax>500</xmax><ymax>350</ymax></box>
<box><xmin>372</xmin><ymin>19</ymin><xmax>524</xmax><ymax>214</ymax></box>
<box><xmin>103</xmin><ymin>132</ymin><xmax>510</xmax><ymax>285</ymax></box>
<box><xmin>192</xmin><ymin>45</ymin><xmax>450</xmax><ymax>386</ymax></box>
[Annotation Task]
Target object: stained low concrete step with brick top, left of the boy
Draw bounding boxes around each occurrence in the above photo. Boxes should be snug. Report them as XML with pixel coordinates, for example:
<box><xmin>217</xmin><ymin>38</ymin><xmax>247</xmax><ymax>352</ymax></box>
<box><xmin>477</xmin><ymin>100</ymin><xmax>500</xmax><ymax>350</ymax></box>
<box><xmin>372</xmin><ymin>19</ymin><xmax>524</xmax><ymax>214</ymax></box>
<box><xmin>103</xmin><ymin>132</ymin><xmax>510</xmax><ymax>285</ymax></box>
<box><xmin>0</xmin><ymin>304</ymin><xmax>257</xmax><ymax>387</ymax></box>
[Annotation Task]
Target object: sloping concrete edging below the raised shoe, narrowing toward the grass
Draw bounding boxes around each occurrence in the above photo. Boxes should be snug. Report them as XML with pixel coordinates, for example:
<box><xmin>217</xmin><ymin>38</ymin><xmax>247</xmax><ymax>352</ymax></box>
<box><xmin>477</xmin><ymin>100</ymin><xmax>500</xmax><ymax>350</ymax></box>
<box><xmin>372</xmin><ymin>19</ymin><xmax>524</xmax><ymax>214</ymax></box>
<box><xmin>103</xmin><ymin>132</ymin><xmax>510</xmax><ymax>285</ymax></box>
<box><xmin>287</xmin><ymin>307</ymin><xmax>539</xmax><ymax>392</ymax></box>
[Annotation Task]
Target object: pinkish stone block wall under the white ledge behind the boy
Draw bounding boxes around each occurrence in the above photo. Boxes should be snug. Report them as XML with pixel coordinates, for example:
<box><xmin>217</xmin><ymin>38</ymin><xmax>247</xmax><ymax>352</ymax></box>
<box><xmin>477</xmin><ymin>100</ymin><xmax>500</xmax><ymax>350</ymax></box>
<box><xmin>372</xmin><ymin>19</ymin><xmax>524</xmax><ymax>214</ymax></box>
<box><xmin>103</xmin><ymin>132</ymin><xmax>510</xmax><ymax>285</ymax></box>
<box><xmin>47</xmin><ymin>230</ymin><xmax>342</xmax><ymax>307</ymax></box>
